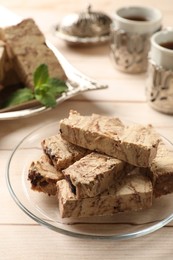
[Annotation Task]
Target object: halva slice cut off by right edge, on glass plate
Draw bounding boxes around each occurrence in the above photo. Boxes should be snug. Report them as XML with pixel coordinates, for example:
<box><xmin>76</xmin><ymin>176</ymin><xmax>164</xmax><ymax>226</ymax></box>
<box><xmin>150</xmin><ymin>142</ymin><xmax>173</xmax><ymax>197</ymax></box>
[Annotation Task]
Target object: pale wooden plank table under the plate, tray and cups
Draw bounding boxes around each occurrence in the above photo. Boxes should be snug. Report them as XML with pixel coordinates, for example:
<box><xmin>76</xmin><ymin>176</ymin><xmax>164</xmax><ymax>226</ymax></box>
<box><xmin>0</xmin><ymin>0</ymin><xmax>173</xmax><ymax>260</ymax></box>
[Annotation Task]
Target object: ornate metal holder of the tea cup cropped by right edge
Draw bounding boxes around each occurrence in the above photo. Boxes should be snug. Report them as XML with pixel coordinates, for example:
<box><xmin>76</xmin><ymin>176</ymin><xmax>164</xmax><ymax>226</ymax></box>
<box><xmin>146</xmin><ymin>60</ymin><xmax>173</xmax><ymax>115</ymax></box>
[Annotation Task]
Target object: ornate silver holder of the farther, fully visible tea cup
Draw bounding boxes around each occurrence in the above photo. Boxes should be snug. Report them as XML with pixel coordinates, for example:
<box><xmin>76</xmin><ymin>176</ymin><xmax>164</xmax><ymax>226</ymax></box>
<box><xmin>110</xmin><ymin>28</ymin><xmax>151</xmax><ymax>73</ymax></box>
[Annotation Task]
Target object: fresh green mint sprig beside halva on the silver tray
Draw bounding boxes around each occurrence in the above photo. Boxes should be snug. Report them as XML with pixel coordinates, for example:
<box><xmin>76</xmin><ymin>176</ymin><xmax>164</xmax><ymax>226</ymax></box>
<box><xmin>5</xmin><ymin>64</ymin><xmax>68</xmax><ymax>107</ymax></box>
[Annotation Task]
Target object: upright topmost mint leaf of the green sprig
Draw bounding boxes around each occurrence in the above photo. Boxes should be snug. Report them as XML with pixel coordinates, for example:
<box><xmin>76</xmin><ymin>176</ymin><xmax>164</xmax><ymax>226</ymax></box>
<box><xmin>34</xmin><ymin>64</ymin><xmax>49</xmax><ymax>87</ymax></box>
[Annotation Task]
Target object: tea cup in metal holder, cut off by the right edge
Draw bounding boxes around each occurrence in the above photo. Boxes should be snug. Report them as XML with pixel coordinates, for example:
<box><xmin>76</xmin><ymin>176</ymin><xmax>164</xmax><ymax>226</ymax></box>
<box><xmin>146</xmin><ymin>28</ymin><xmax>173</xmax><ymax>114</ymax></box>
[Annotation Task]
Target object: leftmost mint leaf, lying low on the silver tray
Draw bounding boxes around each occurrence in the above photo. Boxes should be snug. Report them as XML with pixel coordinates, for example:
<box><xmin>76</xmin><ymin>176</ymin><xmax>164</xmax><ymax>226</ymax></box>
<box><xmin>4</xmin><ymin>88</ymin><xmax>34</xmax><ymax>107</ymax></box>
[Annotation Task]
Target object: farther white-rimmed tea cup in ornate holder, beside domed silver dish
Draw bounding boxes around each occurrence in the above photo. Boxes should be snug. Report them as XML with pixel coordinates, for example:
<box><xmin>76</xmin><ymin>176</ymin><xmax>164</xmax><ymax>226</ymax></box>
<box><xmin>110</xmin><ymin>6</ymin><xmax>162</xmax><ymax>73</ymax></box>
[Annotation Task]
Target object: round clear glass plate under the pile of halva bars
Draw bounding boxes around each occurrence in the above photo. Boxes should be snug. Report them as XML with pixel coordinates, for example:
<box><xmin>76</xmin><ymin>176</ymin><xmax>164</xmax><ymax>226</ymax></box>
<box><xmin>6</xmin><ymin>122</ymin><xmax>173</xmax><ymax>240</ymax></box>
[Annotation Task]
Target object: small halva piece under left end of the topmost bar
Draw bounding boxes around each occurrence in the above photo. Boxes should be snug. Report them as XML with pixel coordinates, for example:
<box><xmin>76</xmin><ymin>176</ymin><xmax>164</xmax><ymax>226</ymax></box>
<box><xmin>41</xmin><ymin>134</ymin><xmax>88</xmax><ymax>170</ymax></box>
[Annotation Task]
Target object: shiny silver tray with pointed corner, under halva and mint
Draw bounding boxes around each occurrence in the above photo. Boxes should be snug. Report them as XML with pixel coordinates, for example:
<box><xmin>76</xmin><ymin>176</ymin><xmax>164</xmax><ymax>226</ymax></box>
<box><xmin>0</xmin><ymin>41</ymin><xmax>108</xmax><ymax>120</ymax></box>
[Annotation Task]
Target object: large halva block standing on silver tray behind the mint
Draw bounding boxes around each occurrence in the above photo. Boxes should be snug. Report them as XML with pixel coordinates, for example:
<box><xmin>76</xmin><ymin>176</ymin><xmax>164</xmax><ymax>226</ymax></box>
<box><xmin>1</xmin><ymin>19</ymin><xmax>66</xmax><ymax>89</ymax></box>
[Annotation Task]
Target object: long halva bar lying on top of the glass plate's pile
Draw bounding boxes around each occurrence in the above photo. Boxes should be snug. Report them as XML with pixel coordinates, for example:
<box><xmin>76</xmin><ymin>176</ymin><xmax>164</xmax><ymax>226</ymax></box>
<box><xmin>60</xmin><ymin>111</ymin><xmax>159</xmax><ymax>167</ymax></box>
